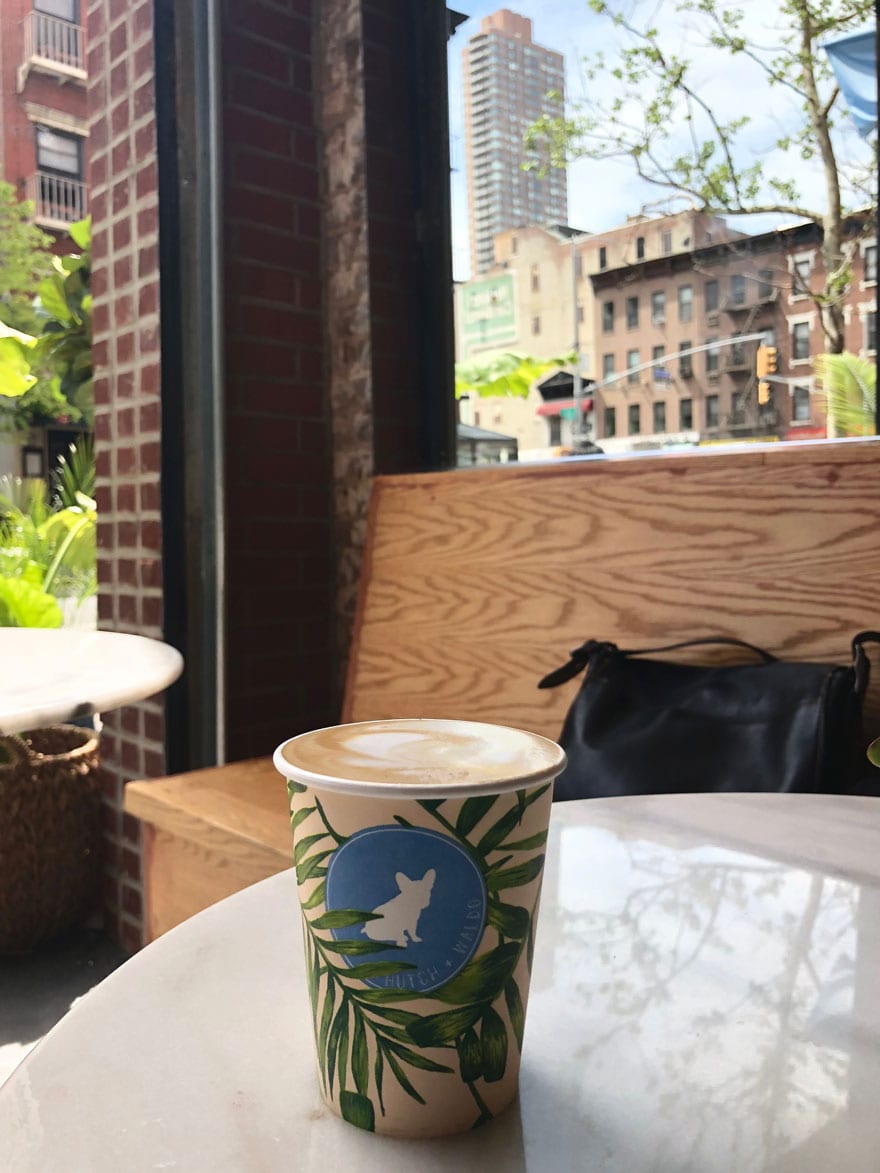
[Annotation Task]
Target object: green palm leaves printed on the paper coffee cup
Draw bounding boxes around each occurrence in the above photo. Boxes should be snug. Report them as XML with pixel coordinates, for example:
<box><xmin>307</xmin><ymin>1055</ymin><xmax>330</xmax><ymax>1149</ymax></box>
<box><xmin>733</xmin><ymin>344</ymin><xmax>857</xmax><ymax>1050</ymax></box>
<box><xmin>287</xmin><ymin>780</ymin><xmax>548</xmax><ymax>1131</ymax></box>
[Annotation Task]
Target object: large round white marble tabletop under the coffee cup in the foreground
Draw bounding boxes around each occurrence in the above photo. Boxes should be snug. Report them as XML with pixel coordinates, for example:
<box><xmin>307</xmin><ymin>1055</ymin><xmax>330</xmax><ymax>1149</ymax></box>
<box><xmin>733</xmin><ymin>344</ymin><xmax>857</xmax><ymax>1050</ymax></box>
<box><xmin>0</xmin><ymin>794</ymin><xmax>880</xmax><ymax>1173</ymax></box>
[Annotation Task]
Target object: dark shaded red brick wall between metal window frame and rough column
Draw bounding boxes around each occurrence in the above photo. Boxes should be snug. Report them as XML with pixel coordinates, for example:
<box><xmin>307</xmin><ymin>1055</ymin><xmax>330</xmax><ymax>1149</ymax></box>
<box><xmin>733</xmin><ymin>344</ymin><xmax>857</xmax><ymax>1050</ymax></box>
<box><xmin>223</xmin><ymin>0</ymin><xmax>338</xmax><ymax>760</ymax></box>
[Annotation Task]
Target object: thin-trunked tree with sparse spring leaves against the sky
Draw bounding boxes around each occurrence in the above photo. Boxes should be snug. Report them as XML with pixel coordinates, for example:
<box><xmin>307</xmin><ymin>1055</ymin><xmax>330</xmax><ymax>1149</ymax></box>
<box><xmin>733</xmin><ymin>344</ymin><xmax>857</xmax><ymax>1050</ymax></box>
<box><xmin>527</xmin><ymin>0</ymin><xmax>876</xmax><ymax>353</ymax></box>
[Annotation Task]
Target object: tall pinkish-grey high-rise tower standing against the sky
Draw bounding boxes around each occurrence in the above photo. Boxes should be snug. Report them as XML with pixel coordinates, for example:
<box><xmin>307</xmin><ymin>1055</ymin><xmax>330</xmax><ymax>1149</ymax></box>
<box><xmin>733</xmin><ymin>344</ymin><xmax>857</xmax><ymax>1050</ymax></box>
<box><xmin>462</xmin><ymin>8</ymin><xmax>568</xmax><ymax>273</ymax></box>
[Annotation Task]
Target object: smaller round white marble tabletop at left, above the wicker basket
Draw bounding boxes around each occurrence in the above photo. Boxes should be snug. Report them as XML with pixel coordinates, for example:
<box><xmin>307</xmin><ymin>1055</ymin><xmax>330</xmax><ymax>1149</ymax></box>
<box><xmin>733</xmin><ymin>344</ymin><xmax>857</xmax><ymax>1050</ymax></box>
<box><xmin>0</xmin><ymin>628</ymin><xmax>183</xmax><ymax>733</ymax></box>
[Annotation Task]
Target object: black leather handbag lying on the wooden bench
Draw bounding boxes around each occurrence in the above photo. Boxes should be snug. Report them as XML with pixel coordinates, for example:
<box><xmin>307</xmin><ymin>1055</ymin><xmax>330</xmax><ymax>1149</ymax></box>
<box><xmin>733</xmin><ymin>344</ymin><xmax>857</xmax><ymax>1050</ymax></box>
<box><xmin>539</xmin><ymin>631</ymin><xmax>880</xmax><ymax>801</ymax></box>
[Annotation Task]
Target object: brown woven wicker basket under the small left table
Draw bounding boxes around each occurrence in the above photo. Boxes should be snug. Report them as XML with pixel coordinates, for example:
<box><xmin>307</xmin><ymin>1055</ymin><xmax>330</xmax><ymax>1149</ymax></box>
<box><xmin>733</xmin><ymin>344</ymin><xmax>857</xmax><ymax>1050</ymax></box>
<box><xmin>0</xmin><ymin>725</ymin><xmax>101</xmax><ymax>954</ymax></box>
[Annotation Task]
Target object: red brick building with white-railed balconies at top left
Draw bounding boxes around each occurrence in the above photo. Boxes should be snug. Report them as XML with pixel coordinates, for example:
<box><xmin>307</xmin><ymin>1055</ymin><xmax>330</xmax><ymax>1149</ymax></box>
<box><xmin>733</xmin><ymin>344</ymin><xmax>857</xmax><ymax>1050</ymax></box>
<box><xmin>0</xmin><ymin>0</ymin><xmax>88</xmax><ymax>233</ymax></box>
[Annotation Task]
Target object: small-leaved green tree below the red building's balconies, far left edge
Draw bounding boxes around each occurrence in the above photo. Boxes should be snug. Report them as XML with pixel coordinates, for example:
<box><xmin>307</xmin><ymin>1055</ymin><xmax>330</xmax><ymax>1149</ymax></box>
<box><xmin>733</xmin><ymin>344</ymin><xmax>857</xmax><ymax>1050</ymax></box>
<box><xmin>0</xmin><ymin>179</ymin><xmax>52</xmax><ymax>334</ymax></box>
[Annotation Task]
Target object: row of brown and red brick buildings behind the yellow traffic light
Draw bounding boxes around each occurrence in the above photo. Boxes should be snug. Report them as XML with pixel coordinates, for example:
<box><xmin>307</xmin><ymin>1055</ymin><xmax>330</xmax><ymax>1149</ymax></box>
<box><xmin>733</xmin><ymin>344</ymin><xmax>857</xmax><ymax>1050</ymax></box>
<box><xmin>590</xmin><ymin>224</ymin><xmax>876</xmax><ymax>450</ymax></box>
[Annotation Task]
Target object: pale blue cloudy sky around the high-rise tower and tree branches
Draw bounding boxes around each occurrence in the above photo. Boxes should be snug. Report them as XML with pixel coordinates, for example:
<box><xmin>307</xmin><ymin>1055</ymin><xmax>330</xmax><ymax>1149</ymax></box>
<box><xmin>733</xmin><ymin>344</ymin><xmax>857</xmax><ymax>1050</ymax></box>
<box><xmin>448</xmin><ymin>0</ymin><xmax>866</xmax><ymax>280</ymax></box>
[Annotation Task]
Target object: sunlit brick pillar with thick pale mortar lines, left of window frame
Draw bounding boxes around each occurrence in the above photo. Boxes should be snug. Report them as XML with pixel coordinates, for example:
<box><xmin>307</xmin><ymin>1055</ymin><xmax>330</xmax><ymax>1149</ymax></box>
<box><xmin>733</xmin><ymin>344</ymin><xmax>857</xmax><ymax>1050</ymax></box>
<box><xmin>87</xmin><ymin>0</ymin><xmax>164</xmax><ymax>949</ymax></box>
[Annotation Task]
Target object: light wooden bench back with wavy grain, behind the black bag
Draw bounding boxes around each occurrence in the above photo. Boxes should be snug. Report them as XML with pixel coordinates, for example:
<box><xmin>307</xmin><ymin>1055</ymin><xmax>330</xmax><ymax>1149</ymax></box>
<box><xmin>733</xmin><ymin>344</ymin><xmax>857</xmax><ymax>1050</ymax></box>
<box><xmin>343</xmin><ymin>440</ymin><xmax>880</xmax><ymax>737</ymax></box>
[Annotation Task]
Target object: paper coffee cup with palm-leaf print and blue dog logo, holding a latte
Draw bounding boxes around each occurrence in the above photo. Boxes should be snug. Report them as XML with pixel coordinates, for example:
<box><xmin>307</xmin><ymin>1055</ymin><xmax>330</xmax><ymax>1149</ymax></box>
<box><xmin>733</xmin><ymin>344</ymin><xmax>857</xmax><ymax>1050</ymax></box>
<box><xmin>275</xmin><ymin>720</ymin><xmax>566</xmax><ymax>1137</ymax></box>
